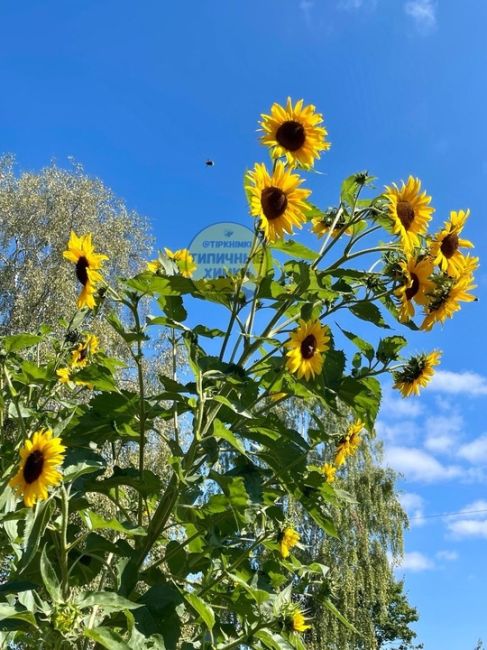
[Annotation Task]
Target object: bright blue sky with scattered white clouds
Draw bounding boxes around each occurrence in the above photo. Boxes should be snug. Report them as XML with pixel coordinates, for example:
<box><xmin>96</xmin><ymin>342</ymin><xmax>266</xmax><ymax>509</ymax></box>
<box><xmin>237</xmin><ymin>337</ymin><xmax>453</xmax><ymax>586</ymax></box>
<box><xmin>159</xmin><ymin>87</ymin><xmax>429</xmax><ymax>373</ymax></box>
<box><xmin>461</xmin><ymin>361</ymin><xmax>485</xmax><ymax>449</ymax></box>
<box><xmin>0</xmin><ymin>0</ymin><xmax>487</xmax><ymax>650</ymax></box>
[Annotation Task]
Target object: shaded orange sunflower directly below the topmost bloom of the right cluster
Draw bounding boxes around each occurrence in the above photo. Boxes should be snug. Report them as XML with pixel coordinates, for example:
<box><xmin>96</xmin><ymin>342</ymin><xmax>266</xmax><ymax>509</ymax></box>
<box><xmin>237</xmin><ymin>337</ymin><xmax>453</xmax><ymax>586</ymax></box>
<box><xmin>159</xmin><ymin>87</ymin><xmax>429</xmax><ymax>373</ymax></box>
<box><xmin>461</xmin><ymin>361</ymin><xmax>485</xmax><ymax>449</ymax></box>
<box><xmin>395</xmin><ymin>257</ymin><xmax>435</xmax><ymax>323</ymax></box>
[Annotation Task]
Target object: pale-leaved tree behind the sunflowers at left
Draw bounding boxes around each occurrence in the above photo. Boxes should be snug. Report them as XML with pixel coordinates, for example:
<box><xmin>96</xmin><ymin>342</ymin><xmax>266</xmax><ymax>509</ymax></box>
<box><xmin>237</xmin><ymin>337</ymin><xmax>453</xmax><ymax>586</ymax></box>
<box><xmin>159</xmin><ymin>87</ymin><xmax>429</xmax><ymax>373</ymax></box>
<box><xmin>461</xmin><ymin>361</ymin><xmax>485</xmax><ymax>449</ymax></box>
<box><xmin>0</xmin><ymin>156</ymin><xmax>152</xmax><ymax>342</ymax></box>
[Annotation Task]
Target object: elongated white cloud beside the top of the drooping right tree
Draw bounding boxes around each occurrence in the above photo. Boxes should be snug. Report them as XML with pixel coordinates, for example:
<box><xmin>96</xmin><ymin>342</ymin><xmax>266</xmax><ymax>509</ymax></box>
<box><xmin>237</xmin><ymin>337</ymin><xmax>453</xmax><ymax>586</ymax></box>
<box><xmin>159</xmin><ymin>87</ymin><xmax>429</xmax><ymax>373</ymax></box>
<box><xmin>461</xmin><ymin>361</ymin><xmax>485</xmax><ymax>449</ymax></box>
<box><xmin>384</xmin><ymin>446</ymin><xmax>461</xmax><ymax>483</ymax></box>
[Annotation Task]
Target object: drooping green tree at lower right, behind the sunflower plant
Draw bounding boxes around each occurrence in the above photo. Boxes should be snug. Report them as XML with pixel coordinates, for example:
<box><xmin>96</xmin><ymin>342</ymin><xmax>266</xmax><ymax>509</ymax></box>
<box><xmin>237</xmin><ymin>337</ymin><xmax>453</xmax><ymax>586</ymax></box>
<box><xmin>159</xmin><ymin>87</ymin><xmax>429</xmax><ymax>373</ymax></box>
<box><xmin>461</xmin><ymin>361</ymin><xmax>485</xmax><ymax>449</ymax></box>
<box><xmin>294</xmin><ymin>423</ymin><xmax>422</xmax><ymax>650</ymax></box>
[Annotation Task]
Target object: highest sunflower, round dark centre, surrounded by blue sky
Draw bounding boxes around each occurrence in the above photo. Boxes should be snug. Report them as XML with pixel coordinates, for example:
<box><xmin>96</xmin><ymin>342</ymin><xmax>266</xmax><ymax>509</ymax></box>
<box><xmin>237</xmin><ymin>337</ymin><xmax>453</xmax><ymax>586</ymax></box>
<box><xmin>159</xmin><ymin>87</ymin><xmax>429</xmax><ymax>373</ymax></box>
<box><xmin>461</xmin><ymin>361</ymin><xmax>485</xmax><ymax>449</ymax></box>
<box><xmin>260</xmin><ymin>97</ymin><xmax>331</xmax><ymax>169</ymax></box>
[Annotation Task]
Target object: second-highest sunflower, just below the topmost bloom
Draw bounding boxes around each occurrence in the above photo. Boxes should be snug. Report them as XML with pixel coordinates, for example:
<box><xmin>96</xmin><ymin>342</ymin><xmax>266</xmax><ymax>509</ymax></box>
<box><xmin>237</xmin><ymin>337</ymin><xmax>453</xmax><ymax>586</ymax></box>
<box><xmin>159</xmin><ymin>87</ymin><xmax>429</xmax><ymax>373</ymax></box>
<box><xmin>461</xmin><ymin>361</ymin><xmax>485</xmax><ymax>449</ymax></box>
<box><xmin>245</xmin><ymin>161</ymin><xmax>311</xmax><ymax>242</ymax></box>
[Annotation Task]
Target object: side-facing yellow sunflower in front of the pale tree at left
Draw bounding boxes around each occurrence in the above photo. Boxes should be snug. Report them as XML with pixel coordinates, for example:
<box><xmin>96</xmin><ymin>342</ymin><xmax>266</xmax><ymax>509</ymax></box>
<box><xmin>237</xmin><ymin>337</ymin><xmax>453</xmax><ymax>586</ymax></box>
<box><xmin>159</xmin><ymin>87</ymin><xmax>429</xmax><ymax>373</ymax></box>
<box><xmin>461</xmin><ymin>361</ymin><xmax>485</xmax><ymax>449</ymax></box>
<box><xmin>63</xmin><ymin>230</ymin><xmax>108</xmax><ymax>309</ymax></box>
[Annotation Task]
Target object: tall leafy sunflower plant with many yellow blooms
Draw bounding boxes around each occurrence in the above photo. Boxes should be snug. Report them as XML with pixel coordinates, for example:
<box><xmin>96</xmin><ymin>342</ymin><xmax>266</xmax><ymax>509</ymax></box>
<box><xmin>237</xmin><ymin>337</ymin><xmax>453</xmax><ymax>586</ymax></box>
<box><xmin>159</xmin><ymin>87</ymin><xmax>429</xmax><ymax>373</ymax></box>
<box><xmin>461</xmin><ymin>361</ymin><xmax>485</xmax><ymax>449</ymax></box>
<box><xmin>0</xmin><ymin>99</ymin><xmax>478</xmax><ymax>650</ymax></box>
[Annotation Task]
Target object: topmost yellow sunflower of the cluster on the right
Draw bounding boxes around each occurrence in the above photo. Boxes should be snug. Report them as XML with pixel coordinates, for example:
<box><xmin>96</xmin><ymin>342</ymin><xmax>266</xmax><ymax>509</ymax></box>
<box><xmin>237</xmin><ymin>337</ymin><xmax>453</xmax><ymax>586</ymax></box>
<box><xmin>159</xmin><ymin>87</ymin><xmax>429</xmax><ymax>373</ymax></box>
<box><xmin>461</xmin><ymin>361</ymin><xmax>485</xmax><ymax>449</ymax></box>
<box><xmin>385</xmin><ymin>176</ymin><xmax>434</xmax><ymax>255</ymax></box>
